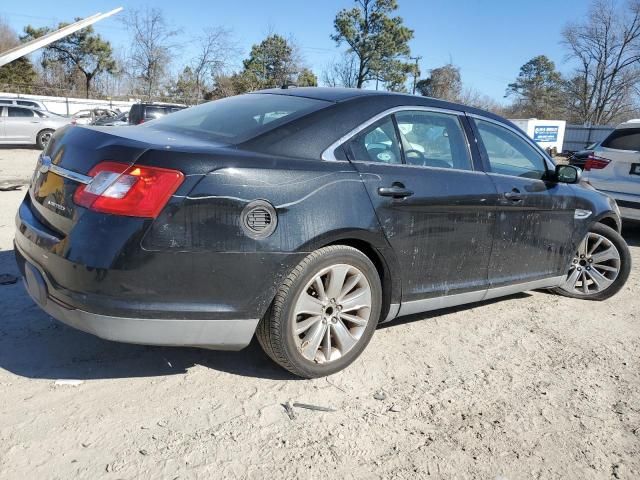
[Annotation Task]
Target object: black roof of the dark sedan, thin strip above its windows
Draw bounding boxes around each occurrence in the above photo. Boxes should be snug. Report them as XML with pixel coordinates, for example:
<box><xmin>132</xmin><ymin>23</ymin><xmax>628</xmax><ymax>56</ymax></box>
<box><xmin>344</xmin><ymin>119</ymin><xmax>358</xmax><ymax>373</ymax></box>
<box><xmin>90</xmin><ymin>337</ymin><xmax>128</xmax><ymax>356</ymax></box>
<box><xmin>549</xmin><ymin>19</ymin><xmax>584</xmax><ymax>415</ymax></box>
<box><xmin>251</xmin><ymin>87</ymin><xmax>512</xmax><ymax>125</ymax></box>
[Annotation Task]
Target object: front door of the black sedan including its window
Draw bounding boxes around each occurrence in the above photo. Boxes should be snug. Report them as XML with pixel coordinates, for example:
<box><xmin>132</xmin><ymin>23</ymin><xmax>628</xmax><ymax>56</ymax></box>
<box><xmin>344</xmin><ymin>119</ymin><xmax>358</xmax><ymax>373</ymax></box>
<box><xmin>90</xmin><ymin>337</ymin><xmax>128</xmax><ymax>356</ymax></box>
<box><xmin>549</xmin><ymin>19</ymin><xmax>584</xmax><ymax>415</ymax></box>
<box><xmin>474</xmin><ymin>117</ymin><xmax>576</xmax><ymax>287</ymax></box>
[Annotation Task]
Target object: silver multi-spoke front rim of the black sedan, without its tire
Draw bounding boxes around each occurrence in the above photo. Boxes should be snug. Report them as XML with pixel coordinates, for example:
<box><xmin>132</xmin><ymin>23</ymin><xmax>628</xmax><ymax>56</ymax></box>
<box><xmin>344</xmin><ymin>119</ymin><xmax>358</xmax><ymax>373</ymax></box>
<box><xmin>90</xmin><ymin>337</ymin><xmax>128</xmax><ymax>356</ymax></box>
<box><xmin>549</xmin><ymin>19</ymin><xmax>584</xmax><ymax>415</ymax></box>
<box><xmin>562</xmin><ymin>232</ymin><xmax>621</xmax><ymax>296</ymax></box>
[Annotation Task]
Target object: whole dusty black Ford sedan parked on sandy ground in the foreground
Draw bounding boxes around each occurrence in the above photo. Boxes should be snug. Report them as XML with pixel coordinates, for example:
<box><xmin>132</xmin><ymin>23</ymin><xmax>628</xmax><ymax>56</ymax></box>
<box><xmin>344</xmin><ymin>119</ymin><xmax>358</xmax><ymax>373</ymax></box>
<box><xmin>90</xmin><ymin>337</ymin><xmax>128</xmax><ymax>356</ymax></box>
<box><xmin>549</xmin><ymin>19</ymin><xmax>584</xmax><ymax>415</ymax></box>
<box><xmin>15</xmin><ymin>88</ymin><xmax>631</xmax><ymax>377</ymax></box>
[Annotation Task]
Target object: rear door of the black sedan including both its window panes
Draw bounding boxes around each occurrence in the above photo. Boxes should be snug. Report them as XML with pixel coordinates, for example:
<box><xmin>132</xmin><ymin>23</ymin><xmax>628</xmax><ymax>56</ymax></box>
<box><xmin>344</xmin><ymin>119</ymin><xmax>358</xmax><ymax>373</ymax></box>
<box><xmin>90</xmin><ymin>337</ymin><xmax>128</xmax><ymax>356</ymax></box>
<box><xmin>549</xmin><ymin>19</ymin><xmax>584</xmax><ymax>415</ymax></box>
<box><xmin>345</xmin><ymin>107</ymin><xmax>496</xmax><ymax>315</ymax></box>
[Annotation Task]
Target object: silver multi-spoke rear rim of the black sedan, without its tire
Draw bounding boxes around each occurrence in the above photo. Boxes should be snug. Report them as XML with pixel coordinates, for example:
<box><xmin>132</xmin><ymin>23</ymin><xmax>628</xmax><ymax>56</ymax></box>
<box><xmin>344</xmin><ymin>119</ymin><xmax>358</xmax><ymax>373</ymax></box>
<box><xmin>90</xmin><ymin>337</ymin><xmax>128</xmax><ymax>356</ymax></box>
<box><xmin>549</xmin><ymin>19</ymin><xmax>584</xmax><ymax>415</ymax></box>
<box><xmin>291</xmin><ymin>264</ymin><xmax>371</xmax><ymax>363</ymax></box>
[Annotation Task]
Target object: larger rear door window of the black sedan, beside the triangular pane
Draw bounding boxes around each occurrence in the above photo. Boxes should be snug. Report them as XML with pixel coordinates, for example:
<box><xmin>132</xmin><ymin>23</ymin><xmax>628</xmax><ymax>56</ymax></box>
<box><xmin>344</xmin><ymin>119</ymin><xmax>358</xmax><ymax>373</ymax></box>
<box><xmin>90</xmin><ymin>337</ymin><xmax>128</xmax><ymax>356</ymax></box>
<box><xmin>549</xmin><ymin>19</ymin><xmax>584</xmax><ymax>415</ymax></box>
<box><xmin>396</xmin><ymin>111</ymin><xmax>472</xmax><ymax>170</ymax></box>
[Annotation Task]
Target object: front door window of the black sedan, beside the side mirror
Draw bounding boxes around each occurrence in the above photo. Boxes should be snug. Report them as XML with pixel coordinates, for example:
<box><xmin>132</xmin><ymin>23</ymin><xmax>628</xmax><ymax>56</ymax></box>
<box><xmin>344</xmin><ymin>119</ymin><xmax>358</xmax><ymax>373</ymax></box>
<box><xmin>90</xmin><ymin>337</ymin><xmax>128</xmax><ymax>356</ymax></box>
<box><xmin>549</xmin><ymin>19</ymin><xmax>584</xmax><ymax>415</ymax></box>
<box><xmin>475</xmin><ymin>120</ymin><xmax>547</xmax><ymax>180</ymax></box>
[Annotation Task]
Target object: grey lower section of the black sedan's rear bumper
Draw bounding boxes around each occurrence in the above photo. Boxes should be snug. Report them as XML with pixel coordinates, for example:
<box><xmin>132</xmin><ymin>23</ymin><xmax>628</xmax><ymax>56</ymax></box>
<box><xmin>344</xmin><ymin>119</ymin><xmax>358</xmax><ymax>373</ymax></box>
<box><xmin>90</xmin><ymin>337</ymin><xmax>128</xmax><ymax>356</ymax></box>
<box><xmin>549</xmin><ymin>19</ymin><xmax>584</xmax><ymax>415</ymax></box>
<box><xmin>15</xmin><ymin>245</ymin><xmax>259</xmax><ymax>350</ymax></box>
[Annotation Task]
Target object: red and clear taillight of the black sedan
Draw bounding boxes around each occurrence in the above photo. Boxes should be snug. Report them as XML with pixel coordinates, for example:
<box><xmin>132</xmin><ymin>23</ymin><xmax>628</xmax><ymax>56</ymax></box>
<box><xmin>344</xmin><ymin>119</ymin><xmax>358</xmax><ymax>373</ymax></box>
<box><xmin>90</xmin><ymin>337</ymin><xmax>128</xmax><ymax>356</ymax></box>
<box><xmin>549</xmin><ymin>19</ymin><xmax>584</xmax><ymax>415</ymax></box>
<box><xmin>73</xmin><ymin>162</ymin><xmax>184</xmax><ymax>218</ymax></box>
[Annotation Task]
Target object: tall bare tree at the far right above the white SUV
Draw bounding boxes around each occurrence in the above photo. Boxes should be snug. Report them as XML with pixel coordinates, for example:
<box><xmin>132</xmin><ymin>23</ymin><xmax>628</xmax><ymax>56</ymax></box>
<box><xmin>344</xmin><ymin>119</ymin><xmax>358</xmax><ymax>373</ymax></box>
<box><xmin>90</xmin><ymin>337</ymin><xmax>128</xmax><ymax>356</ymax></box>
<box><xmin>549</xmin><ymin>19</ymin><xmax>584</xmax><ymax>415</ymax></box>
<box><xmin>562</xmin><ymin>0</ymin><xmax>640</xmax><ymax>125</ymax></box>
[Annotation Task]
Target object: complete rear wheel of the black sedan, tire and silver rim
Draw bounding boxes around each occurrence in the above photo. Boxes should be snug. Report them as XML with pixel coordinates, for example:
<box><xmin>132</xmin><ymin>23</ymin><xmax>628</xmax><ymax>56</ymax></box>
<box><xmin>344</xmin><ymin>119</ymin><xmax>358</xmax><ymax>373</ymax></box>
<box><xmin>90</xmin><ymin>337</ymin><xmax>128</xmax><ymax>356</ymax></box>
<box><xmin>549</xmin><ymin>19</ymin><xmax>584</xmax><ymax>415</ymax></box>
<box><xmin>256</xmin><ymin>245</ymin><xmax>382</xmax><ymax>378</ymax></box>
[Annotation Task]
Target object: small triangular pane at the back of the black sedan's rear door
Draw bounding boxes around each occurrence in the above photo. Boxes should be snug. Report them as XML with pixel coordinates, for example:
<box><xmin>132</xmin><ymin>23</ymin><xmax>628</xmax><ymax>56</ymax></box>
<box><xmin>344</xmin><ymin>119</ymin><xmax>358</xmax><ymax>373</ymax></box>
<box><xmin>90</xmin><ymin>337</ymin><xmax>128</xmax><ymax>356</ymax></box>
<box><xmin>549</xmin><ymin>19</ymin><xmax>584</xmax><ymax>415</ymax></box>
<box><xmin>347</xmin><ymin>117</ymin><xmax>402</xmax><ymax>164</ymax></box>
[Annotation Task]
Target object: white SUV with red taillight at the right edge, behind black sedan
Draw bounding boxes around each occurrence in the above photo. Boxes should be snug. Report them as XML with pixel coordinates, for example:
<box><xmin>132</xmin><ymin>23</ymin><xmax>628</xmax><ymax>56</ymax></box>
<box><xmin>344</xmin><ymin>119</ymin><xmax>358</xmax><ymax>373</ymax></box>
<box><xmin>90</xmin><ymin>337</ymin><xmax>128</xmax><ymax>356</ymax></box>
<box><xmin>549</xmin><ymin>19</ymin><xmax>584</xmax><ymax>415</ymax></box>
<box><xmin>584</xmin><ymin>119</ymin><xmax>640</xmax><ymax>220</ymax></box>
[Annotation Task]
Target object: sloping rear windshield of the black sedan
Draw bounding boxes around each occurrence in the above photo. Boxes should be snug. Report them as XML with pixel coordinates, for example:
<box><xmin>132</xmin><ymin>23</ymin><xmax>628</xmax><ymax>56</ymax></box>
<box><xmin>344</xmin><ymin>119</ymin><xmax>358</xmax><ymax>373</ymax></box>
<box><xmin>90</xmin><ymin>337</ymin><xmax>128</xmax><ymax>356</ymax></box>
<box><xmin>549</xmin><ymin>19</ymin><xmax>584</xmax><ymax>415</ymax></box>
<box><xmin>144</xmin><ymin>93</ymin><xmax>330</xmax><ymax>144</ymax></box>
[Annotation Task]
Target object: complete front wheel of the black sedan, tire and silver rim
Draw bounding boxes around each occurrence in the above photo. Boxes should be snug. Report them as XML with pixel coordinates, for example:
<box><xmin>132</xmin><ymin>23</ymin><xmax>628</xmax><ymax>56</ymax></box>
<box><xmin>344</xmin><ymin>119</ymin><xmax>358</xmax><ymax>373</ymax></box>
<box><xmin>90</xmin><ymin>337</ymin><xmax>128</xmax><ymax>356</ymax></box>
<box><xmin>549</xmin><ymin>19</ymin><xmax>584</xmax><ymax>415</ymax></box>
<box><xmin>553</xmin><ymin>223</ymin><xmax>631</xmax><ymax>300</ymax></box>
